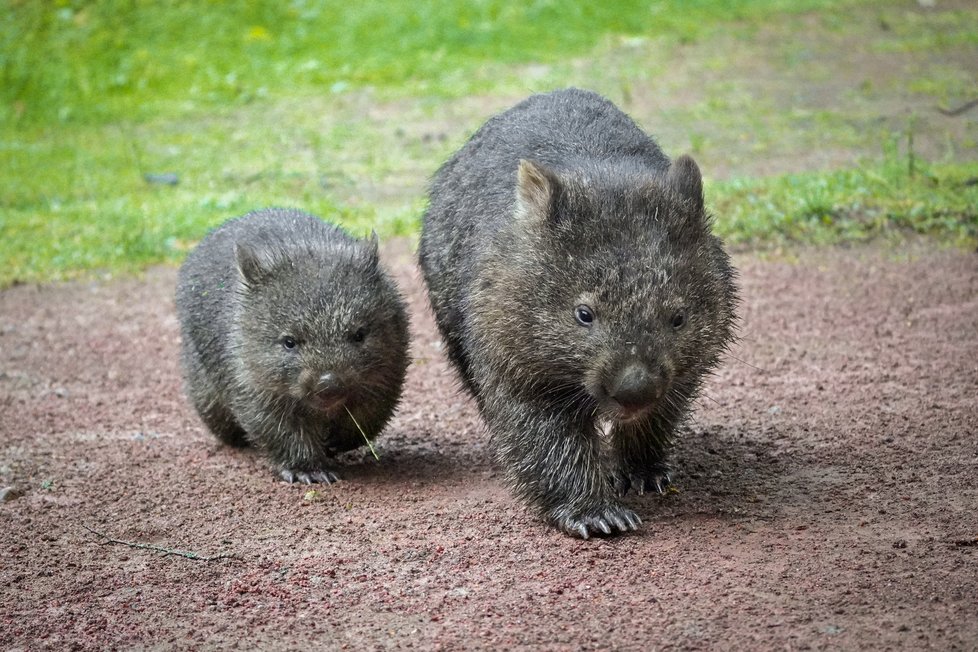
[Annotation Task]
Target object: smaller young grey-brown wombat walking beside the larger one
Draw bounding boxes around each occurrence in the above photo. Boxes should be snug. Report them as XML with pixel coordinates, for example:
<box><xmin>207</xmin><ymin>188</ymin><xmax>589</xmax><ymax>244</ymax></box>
<box><xmin>176</xmin><ymin>209</ymin><xmax>408</xmax><ymax>483</ymax></box>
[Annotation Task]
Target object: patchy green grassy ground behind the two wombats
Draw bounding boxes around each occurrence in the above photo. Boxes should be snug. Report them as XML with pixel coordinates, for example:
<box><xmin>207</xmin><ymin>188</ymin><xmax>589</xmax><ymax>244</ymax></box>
<box><xmin>0</xmin><ymin>0</ymin><xmax>978</xmax><ymax>287</ymax></box>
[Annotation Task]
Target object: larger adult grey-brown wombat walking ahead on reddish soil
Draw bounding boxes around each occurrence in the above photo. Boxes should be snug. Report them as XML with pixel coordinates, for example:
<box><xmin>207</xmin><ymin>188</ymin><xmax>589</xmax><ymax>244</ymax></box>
<box><xmin>419</xmin><ymin>90</ymin><xmax>737</xmax><ymax>538</ymax></box>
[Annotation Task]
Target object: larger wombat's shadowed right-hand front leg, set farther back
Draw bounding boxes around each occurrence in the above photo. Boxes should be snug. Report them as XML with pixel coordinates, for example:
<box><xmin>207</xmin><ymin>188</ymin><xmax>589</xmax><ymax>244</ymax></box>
<box><xmin>611</xmin><ymin>416</ymin><xmax>674</xmax><ymax>496</ymax></box>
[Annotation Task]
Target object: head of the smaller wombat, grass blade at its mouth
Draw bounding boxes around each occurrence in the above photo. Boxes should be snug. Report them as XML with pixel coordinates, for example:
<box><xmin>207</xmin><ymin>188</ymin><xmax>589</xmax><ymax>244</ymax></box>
<box><xmin>235</xmin><ymin>236</ymin><xmax>408</xmax><ymax>414</ymax></box>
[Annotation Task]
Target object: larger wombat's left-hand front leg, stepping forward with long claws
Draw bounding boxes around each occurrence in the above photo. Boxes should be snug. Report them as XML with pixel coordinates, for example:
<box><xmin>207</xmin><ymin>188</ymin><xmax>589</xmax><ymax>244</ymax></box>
<box><xmin>485</xmin><ymin>398</ymin><xmax>642</xmax><ymax>539</ymax></box>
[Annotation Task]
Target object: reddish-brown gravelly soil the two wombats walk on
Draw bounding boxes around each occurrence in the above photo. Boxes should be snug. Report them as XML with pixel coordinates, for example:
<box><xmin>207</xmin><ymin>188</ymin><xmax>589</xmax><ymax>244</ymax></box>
<box><xmin>0</xmin><ymin>244</ymin><xmax>978</xmax><ymax>650</ymax></box>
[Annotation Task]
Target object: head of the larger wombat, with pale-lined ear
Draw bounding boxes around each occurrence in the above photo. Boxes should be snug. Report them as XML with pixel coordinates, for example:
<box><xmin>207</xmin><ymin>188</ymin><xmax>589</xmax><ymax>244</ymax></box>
<box><xmin>476</xmin><ymin>156</ymin><xmax>736</xmax><ymax>421</ymax></box>
